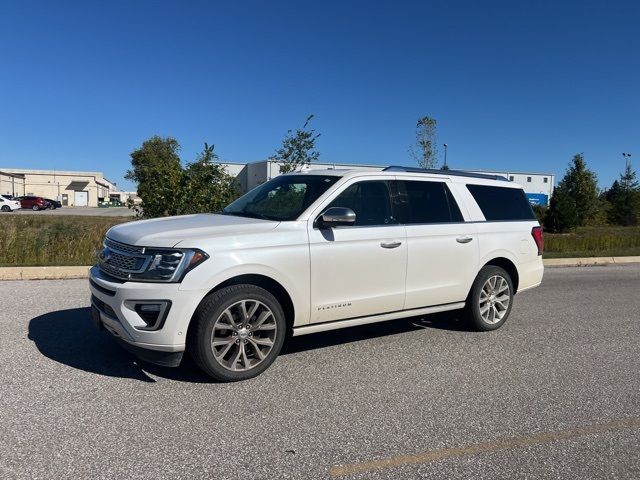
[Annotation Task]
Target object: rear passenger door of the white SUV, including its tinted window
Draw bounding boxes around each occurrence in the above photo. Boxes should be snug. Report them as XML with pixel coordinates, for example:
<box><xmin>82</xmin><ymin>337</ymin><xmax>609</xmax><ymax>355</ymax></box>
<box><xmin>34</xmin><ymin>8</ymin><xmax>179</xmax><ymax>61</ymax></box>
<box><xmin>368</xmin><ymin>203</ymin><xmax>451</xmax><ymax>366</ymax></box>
<box><xmin>397</xmin><ymin>177</ymin><xmax>479</xmax><ymax>309</ymax></box>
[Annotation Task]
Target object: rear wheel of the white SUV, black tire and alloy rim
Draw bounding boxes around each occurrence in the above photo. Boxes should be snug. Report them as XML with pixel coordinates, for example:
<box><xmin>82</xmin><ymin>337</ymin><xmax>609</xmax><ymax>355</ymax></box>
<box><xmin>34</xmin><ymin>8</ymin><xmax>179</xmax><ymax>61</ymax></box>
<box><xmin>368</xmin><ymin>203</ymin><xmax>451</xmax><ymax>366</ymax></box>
<box><xmin>465</xmin><ymin>265</ymin><xmax>514</xmax><ymax>332</ymax></box>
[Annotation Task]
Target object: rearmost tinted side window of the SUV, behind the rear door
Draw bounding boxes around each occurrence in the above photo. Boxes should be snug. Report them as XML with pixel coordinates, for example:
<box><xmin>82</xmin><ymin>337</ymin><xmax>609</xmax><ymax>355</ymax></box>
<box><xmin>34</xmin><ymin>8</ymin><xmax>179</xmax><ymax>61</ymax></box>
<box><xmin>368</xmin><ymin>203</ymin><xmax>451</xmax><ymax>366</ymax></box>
<box><xmin>467</xmin><ymin>184</ymin><xmax>536</xmax><ymax>221</ymax></box>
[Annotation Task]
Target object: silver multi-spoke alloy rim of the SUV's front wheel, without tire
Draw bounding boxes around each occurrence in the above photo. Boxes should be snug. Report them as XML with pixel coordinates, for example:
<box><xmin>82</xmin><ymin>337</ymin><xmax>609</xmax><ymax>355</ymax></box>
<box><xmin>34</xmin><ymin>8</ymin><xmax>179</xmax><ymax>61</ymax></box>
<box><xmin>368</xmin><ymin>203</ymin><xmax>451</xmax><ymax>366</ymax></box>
<box><xmin>211</xmin><ymin>300</ymin><xmax>278</xmax><ymax>372</ymax></box>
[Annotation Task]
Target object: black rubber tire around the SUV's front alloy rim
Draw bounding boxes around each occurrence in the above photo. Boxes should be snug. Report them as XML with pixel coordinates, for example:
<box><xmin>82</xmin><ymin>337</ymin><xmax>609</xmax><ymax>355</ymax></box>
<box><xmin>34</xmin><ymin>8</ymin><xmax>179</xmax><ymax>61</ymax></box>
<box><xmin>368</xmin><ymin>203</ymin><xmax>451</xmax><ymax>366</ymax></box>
<box><xmin>187</xmin><ymin>284</ymin><xmax>287</xmax><ymax>382</ymax></box>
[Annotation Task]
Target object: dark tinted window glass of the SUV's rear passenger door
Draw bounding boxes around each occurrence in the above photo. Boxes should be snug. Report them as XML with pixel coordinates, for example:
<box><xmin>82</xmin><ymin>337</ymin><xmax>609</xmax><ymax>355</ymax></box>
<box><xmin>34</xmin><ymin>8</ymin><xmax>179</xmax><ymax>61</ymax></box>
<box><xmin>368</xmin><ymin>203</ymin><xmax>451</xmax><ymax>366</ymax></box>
<box><xmin>397</xmin><ymin>181</ymin><xmax>464</xmax><ymax>225</ymax></box>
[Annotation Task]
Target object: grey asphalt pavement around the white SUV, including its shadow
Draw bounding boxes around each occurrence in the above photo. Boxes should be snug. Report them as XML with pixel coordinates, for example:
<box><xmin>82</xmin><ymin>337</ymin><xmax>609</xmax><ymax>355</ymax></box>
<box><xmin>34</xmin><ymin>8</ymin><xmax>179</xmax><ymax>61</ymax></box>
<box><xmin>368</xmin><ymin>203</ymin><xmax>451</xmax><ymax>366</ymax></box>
<box><xmin>0</xmin><ymin>265</ymin><xmax>640</xmax><ymax>479</ymax></box>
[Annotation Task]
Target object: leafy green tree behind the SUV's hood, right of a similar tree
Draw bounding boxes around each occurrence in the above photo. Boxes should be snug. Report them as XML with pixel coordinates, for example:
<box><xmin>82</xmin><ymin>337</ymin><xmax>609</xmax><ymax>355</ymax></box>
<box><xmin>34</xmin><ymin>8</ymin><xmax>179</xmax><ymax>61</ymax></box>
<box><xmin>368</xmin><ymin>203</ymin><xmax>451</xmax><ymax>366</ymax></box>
<box><xmin>179</xmin><ymin>143</ymin><xmax>239</xmax><ymax>215</ymax></box>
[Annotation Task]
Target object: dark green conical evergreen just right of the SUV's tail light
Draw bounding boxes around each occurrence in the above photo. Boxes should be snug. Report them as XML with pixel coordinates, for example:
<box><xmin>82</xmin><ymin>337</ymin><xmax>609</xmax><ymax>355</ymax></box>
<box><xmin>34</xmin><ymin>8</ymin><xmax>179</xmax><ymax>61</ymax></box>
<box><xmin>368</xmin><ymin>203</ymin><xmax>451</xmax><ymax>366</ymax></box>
<box><xmin>545</xmin><ymin>153</ymin><xmax>600</xmax><ymax>232</ymax></box>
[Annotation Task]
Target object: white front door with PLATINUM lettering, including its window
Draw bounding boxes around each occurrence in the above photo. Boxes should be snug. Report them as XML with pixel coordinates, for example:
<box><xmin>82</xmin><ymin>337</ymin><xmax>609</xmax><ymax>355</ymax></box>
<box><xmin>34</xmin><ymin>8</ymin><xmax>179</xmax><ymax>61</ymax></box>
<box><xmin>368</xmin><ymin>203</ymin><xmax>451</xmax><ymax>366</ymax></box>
<box><xmin>309</xmin><ymin>180</ymin><xmax>407</xmax><ymax>323</ymax></box>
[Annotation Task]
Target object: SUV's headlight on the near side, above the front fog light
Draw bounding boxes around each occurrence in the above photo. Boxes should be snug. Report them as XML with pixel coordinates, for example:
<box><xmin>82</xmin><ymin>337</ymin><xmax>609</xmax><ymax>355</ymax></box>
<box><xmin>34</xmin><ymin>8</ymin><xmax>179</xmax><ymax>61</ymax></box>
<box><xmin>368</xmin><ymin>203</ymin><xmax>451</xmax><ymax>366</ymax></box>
<box><xmin>130</xmin><ymin>248</ymin><xmax>209</xmax><ymax>282</ymax></box>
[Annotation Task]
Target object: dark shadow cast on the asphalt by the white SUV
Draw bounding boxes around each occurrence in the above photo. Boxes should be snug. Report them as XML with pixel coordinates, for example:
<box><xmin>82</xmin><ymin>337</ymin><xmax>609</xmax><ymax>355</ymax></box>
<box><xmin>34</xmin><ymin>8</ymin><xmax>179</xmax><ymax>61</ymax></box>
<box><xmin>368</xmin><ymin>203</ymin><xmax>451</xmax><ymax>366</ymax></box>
<box><xmin>29</xmin><ymin>307</ymin><xmax>467</xmax><ymax>383</ymax></box>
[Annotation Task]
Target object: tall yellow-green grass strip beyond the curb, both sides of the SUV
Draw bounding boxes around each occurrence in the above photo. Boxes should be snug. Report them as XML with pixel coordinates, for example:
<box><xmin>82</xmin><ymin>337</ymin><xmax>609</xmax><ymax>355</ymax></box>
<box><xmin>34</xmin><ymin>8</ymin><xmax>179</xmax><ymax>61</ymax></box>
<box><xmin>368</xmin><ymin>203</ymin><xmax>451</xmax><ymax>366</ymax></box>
<box><xmin>0</xmin><ymin>214</ymin><xmax>640</xmax><ymax>266</ymax></box>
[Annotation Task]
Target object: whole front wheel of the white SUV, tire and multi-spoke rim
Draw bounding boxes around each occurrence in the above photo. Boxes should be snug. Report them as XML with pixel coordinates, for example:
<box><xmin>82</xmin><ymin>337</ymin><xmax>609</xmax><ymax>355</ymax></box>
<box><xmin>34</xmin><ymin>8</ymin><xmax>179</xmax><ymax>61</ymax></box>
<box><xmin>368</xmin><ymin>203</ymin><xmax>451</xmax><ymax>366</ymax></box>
<box><xmin>189</xmin><ymin>285</ymin><xmax>287</xmax><ymax>382</ymax></box>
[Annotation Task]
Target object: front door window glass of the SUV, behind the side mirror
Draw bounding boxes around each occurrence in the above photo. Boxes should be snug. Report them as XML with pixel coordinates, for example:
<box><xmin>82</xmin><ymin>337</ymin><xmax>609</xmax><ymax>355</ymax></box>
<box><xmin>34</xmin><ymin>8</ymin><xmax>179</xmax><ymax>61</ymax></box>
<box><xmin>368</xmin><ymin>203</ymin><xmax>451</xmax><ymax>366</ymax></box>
<box><xmin>327</xmin><ymin>180</ymin><xmax>397</xmax><ymax>227</ymax></box>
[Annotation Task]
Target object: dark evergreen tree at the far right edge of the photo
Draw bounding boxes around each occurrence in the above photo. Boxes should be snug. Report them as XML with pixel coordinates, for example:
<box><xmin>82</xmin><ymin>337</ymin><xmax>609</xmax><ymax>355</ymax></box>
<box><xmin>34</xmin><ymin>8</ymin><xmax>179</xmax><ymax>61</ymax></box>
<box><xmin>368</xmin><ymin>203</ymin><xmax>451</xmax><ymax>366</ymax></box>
<box><xmin>604</xmin><ymin>163</ymin><xmax>640</xmax><ymax>226</ymax></box>
